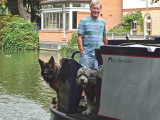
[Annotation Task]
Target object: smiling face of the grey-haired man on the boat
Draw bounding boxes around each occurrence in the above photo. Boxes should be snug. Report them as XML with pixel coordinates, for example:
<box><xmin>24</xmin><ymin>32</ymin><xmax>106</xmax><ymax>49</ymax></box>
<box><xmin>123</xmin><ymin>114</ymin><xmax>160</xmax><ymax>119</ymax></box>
<box><xmin>90</xmin><ymin>4</ymin><xmax>101</xmax><ymax>19</ymax></box>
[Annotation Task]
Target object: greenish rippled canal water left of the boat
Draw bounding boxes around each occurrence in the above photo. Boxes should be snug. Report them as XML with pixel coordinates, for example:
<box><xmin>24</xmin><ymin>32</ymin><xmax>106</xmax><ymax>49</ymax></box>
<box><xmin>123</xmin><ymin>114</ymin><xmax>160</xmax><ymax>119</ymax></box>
<box><xmin>0</xmin><ymin>50</ymin><xmax>72</xmax><ymax>120</ymax></box>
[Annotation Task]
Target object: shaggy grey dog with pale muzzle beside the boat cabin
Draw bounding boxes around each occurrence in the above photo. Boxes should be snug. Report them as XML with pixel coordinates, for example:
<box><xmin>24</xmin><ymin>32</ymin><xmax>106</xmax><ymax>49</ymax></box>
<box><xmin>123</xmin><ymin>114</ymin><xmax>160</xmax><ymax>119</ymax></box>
<box><xmin>76</xmin><ymin>67</ymin><xmax>98</xmax><ymax>115</ymax></box>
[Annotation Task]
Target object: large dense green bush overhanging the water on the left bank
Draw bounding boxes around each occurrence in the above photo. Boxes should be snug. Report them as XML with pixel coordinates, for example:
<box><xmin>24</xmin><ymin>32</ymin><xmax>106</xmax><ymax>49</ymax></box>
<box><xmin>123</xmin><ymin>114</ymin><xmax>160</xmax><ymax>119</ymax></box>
<box><xmin>0</xmin><ymin>16</ymin><xmax>39</xmax><ymax>50</ymax></box>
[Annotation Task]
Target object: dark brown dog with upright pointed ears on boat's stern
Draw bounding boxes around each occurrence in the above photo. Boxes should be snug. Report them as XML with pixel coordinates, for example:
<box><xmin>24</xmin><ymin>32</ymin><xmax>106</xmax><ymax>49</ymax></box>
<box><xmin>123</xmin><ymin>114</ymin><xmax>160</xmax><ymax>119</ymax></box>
<box><xmin>38</xmin><ymin>56</ymin><xmax>61</xmax><ymax>108</ymax></box>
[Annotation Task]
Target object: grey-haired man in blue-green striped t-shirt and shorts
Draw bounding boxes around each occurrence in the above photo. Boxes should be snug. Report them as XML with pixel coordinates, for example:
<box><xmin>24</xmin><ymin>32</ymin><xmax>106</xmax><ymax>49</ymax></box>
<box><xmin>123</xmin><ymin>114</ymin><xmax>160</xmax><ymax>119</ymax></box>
<box><xmin>77</xmin><ymin>1</ymin><xmax>108</xmax><ymax>69</ymax></box>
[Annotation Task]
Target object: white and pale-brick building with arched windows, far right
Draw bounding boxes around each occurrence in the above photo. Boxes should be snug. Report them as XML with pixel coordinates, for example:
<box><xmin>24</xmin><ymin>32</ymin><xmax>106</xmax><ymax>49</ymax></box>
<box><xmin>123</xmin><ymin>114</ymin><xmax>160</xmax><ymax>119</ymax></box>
<box><xmin>123</xmin><ymin>0</ymin><xmax>160</xmax><ymax>35</ymax></box>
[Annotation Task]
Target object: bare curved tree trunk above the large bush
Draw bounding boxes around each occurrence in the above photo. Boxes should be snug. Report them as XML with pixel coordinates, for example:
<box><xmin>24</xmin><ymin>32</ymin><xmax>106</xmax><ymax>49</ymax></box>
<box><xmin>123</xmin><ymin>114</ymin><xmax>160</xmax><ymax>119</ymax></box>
<box><xmin>18</xmin><ymin>0</ymin><xmax>31</xmax><ymax>22</ymax></box>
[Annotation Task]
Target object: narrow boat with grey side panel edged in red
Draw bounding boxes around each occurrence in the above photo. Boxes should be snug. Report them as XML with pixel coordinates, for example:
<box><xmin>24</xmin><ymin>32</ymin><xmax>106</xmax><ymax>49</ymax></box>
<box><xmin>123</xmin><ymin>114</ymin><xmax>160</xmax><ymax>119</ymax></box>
<box><xmin>50</xmin><ymin>40</ymin><xmax>160</xmax><ymax>120</ymax></box>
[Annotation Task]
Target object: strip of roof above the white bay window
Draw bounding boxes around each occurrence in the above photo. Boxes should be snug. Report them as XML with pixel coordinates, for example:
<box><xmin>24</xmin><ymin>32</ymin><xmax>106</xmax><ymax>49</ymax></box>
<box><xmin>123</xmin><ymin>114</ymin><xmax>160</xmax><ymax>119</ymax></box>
<box><xmin>40</xmin><ymin>0</ymin><xmax>92</xmax><ymax>5</ymax></box>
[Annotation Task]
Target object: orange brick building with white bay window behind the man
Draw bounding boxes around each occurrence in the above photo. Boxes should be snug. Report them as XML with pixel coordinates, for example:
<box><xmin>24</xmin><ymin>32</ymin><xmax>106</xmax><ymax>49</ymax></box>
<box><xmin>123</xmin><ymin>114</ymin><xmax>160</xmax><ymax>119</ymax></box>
<box><xmin>39</xmin><ymin>0</ymin><xmax>122</xmax><ymax>43</ymax></box>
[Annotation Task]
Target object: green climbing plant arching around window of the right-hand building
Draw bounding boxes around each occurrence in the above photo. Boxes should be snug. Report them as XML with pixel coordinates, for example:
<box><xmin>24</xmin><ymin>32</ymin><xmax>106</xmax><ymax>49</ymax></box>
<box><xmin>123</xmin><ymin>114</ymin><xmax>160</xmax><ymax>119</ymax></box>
<box><xmin>122</xmin><ymin>11</ymin><xmax>143</xmax><ymax>32</ymax></box>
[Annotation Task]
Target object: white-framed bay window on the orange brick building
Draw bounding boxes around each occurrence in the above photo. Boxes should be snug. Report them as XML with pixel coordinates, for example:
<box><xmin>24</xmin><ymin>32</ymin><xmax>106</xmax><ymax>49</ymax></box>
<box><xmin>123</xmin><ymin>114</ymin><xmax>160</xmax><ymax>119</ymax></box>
<box><xmin>41</xmin><ymin>2</ymin><xmax>89</xmax><ymax>30</ymax></box>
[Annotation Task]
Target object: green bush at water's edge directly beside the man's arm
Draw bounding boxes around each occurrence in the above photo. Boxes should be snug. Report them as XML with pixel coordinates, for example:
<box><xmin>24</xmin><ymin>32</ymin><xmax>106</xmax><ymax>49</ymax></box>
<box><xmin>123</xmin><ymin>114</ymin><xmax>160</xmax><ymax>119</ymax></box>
<box><xmin>60</xmin><ymin>32</ymin><xmax>78</xmax><ymax>57</ymax></box>
